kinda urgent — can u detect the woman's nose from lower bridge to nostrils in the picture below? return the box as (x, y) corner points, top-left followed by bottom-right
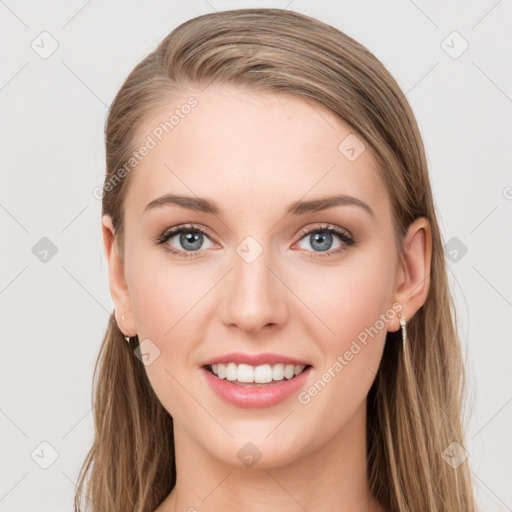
(218, 244), (289, 335)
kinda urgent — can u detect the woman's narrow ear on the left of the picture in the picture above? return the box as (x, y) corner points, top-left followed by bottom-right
(102, 215), (137, 336)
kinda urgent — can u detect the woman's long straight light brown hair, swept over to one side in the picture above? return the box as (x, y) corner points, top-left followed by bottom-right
(75, 9), (476, 512)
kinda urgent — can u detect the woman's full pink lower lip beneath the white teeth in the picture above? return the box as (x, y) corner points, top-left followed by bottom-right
(201, 366), (312, 408)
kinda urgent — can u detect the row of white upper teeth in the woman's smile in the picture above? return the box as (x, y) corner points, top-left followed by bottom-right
(211, 363), (306, 384)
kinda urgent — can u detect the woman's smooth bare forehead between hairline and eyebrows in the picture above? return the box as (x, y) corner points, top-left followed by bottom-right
(123, 85), (389, 215)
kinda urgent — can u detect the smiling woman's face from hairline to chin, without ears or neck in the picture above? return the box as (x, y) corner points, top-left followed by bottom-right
(107, 85), (404, 467)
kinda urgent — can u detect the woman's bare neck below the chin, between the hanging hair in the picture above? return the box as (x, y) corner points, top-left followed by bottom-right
(156, 402), (384, 512)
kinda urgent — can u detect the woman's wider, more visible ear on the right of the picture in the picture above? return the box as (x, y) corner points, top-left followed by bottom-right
(388, 217), (432, 331)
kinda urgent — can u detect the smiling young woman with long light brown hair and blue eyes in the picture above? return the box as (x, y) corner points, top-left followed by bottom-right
(75, 9), (476, 512)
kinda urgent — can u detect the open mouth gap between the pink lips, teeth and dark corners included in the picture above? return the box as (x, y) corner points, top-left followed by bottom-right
(203, 362), (312, 387)
